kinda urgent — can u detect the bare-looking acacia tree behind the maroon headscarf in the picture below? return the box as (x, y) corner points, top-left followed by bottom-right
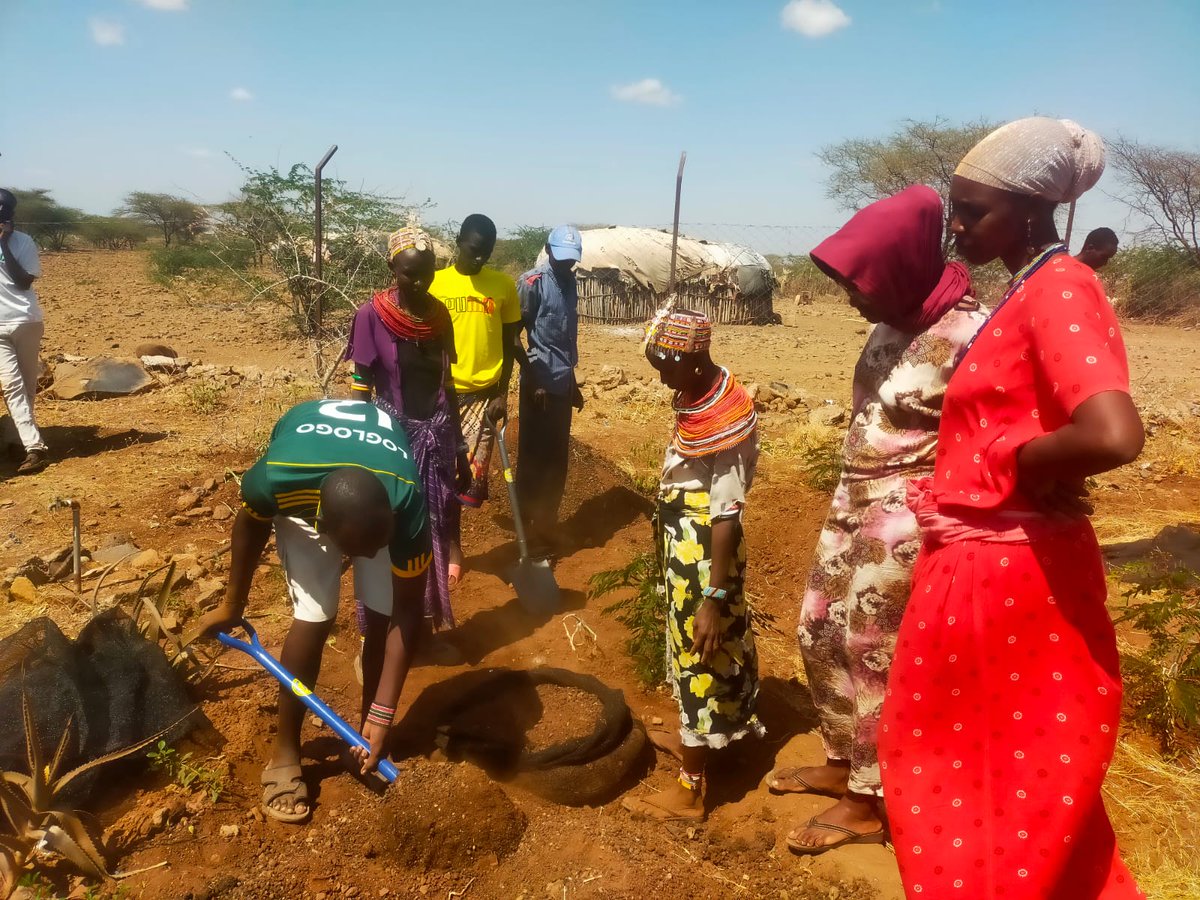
(817, 118), (996, 247)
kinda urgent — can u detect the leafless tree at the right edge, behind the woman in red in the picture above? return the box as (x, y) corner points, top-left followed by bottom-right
(1109, 137), (1200, 265)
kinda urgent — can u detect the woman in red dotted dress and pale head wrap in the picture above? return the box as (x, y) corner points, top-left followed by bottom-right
(880, 118), (1144, 900)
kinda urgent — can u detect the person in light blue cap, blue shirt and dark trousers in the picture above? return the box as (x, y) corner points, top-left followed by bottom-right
(516, 226), (583, 556)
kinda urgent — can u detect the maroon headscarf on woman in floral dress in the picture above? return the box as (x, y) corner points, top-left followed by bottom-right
(809, 185), (971, 334)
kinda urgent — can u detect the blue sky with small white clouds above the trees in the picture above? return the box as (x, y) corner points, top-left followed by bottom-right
(0, 0), (1200, 247)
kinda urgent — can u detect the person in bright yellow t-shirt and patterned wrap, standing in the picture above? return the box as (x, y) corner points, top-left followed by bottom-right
(430, 212), (521, 587)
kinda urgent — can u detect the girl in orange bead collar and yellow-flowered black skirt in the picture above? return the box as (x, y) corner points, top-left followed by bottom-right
(622, 310), (763, 821)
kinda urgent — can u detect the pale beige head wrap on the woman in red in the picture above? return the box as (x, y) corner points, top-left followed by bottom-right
(954, 116), (1104, 203)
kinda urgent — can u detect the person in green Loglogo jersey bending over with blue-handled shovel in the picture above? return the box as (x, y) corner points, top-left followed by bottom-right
(190, 400), (433, 823)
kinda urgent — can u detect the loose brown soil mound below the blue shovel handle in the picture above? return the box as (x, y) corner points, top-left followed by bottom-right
(337, 761), (527, 871)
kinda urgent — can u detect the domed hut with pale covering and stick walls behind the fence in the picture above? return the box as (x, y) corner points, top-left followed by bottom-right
(539, 226), (778, 325)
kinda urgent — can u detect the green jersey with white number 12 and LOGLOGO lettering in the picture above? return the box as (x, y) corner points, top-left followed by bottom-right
(241, 400), (433, 578)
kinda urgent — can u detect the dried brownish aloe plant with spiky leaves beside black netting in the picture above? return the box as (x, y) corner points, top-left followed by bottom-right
(0, 690), (191, 896)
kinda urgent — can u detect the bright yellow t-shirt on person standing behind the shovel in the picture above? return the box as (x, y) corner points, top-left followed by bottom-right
(430, 264), (521, 392)
